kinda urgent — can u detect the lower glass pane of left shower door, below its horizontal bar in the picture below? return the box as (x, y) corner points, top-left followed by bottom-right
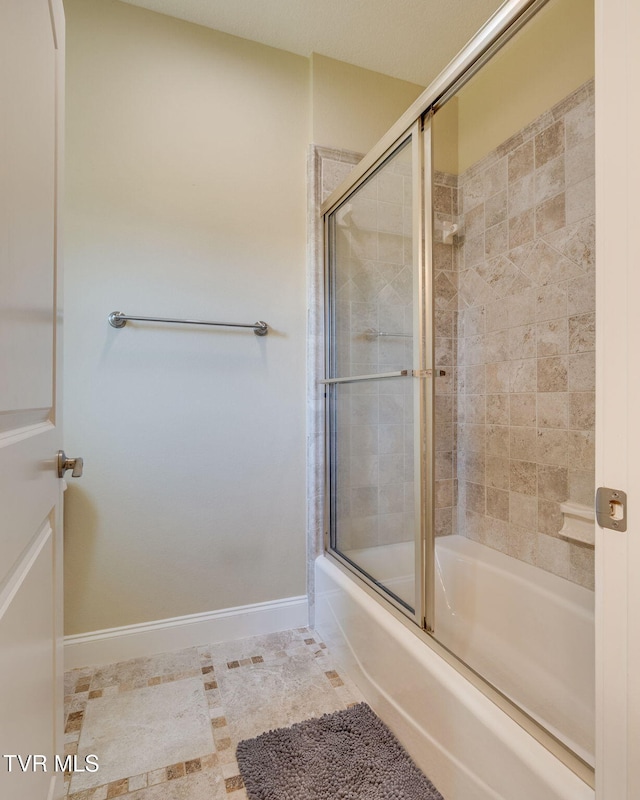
(330, 378), (416, 609)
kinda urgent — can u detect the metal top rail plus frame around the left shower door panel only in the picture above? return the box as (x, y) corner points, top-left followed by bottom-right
(321, 0), (548, 633)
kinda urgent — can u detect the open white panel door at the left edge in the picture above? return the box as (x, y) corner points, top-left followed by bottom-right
(0, 0), (64, 800)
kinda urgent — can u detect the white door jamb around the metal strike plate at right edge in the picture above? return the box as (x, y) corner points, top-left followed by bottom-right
(596, 0), (640, 800)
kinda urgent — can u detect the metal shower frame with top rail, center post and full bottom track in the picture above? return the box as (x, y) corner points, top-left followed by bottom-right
(321, 0), (595, 787)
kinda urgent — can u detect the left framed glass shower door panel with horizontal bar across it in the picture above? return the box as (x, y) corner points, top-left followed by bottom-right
(325, 120), (424, 619)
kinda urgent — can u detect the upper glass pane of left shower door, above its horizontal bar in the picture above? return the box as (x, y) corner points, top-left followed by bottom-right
(329, 139), (414, 378)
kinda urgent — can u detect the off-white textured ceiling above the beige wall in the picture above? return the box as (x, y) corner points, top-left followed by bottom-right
(123, 0), (502, 86)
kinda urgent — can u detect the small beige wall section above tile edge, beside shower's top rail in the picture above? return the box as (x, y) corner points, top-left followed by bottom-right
(311, 53), (424, 154)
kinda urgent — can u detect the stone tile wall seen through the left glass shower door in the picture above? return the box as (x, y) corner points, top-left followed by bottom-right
(336, 153), (414, 550)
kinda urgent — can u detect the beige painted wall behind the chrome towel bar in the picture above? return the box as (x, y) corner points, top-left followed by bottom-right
(65, 0), (419, 634)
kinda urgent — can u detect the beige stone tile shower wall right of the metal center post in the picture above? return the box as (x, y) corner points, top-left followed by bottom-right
(444, 82), (595, 586)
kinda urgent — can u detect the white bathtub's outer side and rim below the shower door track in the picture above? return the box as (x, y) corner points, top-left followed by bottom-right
(316, 556), (594, 800)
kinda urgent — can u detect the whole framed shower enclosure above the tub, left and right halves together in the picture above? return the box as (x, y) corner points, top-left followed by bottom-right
(324, 0), (596, 782)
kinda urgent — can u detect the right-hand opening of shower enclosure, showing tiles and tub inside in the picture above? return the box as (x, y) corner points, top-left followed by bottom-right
(428, 0), (596, 765)
